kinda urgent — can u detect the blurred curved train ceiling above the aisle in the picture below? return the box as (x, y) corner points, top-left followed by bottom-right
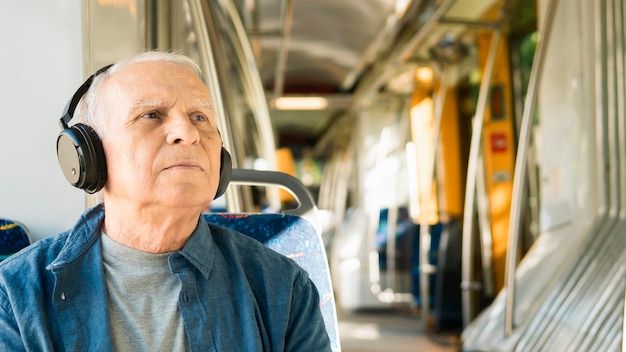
(236, 0), (535, 152)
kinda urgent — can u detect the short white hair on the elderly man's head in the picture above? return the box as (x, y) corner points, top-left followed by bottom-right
(75, 51), (202, 136)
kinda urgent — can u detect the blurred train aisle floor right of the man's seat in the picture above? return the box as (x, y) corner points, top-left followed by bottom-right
(339, 310), (458, 352)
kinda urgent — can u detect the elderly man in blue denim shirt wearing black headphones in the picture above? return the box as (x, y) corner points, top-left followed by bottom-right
(0, 52), (330, 351)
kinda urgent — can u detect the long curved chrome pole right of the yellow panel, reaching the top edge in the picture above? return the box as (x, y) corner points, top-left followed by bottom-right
(504, 0), (558, 336)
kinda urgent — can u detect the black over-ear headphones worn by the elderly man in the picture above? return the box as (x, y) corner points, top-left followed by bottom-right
(57, 65), (232, 198)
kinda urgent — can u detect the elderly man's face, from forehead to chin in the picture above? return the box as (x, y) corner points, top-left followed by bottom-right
(98, 62), (221, 209)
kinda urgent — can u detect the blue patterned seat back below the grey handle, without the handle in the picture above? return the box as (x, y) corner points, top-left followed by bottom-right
(204, 213), (340, 351)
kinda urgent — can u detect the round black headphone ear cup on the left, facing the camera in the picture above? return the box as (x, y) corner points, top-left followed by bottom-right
(57, 123), (107, 194)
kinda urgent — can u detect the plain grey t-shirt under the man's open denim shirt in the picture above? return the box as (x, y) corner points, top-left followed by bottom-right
(102, 233), (189, 351)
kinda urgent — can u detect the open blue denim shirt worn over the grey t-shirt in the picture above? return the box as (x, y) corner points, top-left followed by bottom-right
(0, 206), (330, 351)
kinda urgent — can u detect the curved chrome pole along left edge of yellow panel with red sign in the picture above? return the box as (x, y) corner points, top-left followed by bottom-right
(461, 29), (501, 326)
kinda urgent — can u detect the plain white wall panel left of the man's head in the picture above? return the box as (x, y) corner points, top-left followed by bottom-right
(0, 0), (85, 240)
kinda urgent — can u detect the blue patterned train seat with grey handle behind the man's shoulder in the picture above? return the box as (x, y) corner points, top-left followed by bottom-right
(204, 169), (341, 351)
